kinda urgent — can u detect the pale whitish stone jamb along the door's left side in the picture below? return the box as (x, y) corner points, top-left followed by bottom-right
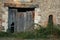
(2, 7), (8, 32)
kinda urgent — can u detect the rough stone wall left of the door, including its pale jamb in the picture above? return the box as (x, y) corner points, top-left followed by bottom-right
(0, 1), (8, 32)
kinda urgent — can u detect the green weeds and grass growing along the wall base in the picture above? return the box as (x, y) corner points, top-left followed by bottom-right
(0, 25), (60, 39)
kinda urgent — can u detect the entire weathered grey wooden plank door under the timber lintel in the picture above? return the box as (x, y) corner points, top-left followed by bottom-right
(8, 8), (34, 32)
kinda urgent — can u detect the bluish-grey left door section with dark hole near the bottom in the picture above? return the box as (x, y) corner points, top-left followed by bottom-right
(8, 9), (17, 32)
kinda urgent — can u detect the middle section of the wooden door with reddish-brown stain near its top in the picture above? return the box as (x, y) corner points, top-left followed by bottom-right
(16, 12), (24, 32)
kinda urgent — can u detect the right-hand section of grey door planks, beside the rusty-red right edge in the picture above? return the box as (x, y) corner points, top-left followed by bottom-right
(24, 11), (34, 31)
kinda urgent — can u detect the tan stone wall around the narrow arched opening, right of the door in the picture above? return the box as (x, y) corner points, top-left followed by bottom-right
(37, 0), (60, 26)
